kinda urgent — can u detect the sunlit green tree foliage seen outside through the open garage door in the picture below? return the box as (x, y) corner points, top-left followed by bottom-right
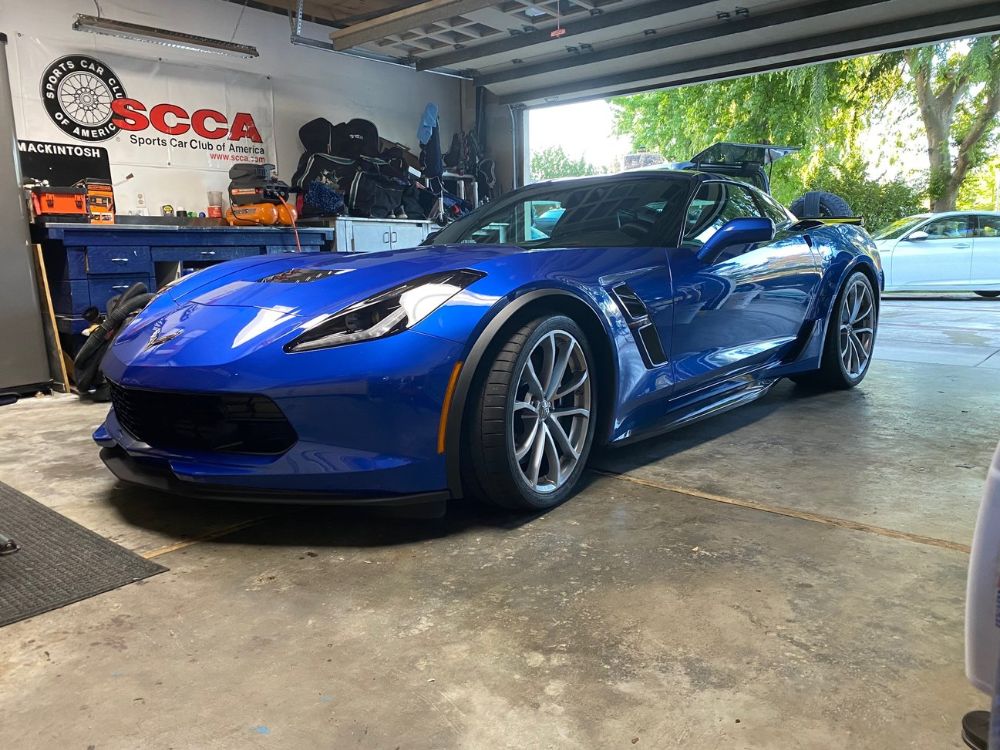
(612, 37), (1000, 216)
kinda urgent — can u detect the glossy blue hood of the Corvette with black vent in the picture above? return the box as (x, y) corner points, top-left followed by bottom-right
(168, 245), (532, 317)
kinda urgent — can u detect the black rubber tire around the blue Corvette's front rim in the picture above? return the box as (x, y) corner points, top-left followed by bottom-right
(462, 314), (597, 510)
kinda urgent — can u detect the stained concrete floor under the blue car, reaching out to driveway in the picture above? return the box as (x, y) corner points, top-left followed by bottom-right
(0, 299), (1000, 750)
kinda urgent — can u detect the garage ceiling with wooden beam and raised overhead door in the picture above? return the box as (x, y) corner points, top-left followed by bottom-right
(270, 0), (1000, 105)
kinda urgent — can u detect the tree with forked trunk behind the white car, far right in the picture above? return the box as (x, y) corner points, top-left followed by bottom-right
(905, 36), (1000, 211)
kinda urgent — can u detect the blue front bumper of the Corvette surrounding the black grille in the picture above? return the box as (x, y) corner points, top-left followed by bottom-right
(94, 319), (461, 504)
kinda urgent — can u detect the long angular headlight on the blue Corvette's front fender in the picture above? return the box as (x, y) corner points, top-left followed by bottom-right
(285, 269), (486, 352)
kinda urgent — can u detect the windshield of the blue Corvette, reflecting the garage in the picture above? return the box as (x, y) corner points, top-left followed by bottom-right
(433, 175), (690, 248)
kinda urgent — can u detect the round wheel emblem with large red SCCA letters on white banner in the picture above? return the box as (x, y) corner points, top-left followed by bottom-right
(42, 55), (262, 143)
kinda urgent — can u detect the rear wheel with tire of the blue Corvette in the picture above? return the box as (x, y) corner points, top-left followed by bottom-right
(792, 271), (878, 389)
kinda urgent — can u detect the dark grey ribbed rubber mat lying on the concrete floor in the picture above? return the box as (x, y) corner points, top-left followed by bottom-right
(0, 482), (167, 627)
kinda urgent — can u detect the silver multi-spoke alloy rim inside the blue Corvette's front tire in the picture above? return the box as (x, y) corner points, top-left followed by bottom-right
(508, 329), (592, 494)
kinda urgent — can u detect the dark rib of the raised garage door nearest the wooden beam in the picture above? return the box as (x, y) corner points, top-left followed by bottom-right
(416, 0), (716, 70)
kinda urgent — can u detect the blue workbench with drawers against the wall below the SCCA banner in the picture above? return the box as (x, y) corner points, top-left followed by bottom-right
(36, 223), (334, 334)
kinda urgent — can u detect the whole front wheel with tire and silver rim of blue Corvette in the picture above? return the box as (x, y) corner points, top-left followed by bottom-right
(463, 315), (597, 510)
